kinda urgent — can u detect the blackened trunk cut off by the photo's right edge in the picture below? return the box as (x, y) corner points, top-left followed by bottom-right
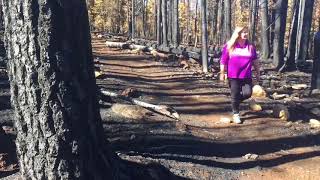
(311, 31), (320, 89)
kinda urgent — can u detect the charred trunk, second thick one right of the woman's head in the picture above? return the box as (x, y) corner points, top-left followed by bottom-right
(273, 0), (288, 70)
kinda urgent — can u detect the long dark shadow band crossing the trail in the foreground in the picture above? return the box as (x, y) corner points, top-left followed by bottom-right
(112, 126), (320, 170)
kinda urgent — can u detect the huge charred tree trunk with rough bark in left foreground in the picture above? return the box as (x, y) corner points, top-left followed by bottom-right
(3, 0), (119, 179)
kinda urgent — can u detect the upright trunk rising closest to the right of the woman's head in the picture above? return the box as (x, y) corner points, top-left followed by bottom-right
(260, 0), (270, 59)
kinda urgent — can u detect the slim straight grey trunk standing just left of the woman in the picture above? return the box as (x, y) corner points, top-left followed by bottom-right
(201, 0), (208, 73)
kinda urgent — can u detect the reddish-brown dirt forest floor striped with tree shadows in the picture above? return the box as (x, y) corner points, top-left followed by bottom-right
(0, 39), (320, 180)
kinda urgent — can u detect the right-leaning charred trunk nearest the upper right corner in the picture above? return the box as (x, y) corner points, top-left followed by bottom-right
(295, 0), (314, 69)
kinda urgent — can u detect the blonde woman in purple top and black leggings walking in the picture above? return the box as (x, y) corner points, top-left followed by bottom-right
(220, 27), (260, 124)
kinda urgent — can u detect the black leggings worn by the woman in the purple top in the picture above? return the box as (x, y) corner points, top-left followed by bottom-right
(229, 78), (252, 114)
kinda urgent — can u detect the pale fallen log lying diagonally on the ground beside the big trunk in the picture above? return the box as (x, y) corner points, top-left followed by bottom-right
(101, 90), (180, 119)
